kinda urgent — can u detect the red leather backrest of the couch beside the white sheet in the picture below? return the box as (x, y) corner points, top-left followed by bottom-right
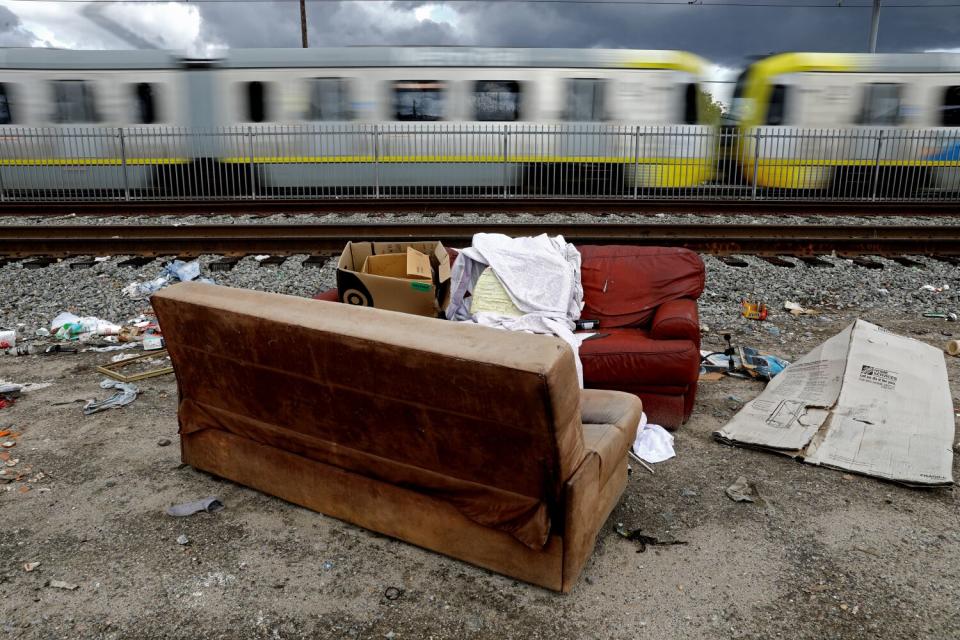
(577, 245), (705, 331)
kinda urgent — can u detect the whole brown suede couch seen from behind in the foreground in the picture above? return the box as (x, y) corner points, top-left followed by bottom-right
(152, 283), (641, 592)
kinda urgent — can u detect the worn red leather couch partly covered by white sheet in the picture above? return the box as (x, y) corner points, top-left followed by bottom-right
(316, 245), (706, 429)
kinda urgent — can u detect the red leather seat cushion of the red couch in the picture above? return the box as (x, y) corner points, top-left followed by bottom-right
(580, 324), (700, 393)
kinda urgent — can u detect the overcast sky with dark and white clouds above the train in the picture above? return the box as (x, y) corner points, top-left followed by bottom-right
(0, 0), (960, 100)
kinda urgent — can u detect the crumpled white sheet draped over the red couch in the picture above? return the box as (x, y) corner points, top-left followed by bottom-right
(446, 233), (588, 388)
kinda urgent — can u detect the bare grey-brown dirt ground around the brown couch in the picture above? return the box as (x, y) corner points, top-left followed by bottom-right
(0, 310), (960, 640)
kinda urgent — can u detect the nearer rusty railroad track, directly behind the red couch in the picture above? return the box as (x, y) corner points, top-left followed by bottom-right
(0, 223), (960, 264)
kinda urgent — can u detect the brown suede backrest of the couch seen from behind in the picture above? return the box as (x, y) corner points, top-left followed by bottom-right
(152, 283), (584, 544)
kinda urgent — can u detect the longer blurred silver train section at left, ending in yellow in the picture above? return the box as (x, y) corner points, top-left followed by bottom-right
(0, 47), (715, 195)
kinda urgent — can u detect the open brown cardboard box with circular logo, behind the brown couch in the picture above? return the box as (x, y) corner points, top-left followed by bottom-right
(337, 242), (450, 318)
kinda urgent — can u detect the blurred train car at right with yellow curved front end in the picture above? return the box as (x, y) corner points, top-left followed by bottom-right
(724, 53), (960, 197)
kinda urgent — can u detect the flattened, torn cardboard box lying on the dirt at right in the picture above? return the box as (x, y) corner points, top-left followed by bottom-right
(714, 320), (954, 486)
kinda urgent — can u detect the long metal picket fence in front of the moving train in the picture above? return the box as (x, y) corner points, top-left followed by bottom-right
(0, 123), (960, 203)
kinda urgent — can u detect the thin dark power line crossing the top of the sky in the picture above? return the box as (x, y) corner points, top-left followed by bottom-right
(6, 0), (960, 9)
